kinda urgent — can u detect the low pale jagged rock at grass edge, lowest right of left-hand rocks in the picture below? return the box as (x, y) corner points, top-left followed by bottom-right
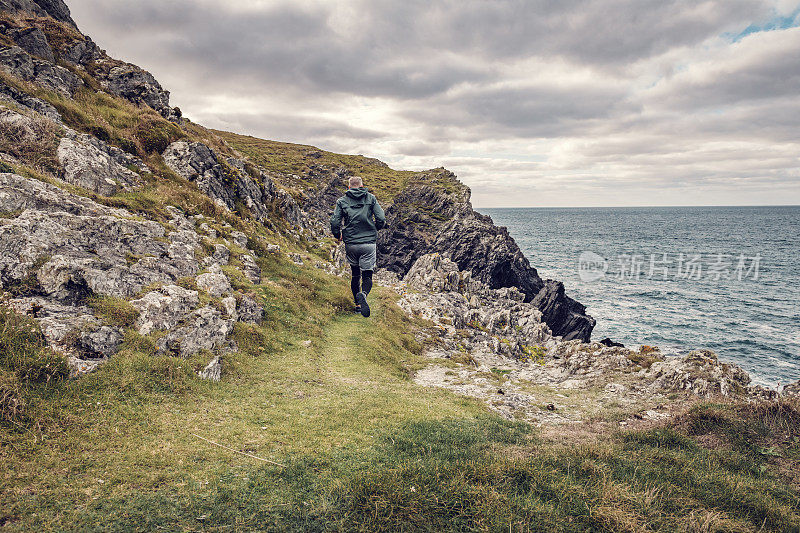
(157, 306), (234, 357)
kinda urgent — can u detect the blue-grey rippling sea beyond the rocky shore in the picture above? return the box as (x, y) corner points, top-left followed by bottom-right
(478, 206), (800, 388)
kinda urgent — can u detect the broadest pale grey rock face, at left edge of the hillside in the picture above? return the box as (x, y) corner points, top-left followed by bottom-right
(0, 174), (199, 303)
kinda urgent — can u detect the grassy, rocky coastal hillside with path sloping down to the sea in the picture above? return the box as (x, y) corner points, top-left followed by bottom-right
(0, 0), (800, 531)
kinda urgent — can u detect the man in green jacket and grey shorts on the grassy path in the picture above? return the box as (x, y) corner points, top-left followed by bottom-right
(331, 176), (386, 317)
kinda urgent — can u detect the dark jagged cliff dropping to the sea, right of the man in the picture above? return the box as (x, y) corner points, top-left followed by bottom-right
(378, 170), (595, 341)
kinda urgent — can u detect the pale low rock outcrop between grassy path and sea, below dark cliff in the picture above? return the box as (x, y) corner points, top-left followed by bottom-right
(398, 254), (775, 423)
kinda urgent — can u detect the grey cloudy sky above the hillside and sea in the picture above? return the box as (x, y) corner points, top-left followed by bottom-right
(67, 0), (800, 207)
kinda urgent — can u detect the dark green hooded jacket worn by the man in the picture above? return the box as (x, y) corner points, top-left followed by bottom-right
(331, 187), (386, 244)
